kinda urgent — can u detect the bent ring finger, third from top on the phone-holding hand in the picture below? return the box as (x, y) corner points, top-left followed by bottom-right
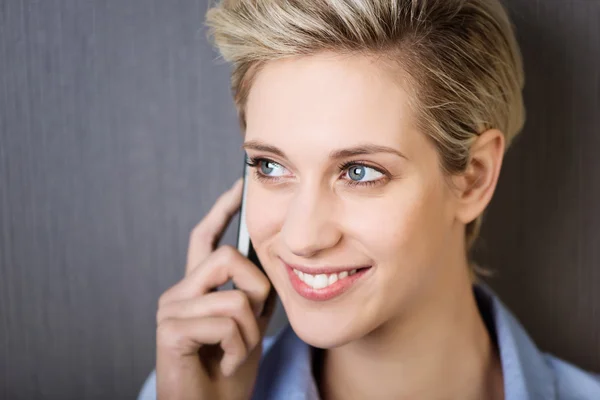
(156, 290), (261, 350)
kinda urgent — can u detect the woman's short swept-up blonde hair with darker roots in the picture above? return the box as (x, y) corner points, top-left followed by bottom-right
(206, 0), (525, 276)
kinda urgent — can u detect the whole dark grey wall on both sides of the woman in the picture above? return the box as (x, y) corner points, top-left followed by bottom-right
(0, 0), (600, 400)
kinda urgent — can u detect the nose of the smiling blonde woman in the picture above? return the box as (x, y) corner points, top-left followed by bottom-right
(281, 184), (342, 257)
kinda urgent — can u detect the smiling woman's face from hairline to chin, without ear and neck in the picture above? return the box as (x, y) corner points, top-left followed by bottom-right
(245, 54), (463, 348)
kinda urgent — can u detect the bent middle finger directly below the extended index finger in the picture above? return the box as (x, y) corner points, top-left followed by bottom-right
(176, 246), (271, 313)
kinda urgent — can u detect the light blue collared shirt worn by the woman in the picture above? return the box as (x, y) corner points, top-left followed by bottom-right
(138, 283), (600, 400)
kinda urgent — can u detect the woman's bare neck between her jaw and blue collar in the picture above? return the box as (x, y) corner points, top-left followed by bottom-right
(315, 268), (504, 400)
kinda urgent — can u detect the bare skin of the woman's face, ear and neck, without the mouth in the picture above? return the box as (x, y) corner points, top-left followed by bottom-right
(244, 53), (505, 400)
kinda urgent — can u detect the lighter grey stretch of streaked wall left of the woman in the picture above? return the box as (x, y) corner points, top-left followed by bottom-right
(0, 0), (243, 399)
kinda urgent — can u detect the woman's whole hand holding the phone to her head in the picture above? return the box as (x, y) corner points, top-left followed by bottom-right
(156, 179), (274, 400)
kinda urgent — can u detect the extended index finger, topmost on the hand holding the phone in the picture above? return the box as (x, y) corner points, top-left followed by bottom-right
(186, 178), (243, 275)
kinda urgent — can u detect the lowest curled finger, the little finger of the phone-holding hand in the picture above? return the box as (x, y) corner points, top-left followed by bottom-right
(156, 317), (248, 376)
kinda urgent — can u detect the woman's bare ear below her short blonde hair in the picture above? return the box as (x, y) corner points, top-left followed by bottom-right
(452, 129), (505, 225)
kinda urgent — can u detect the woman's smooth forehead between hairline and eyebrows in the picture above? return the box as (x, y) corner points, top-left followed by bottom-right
(246, 55), (412, 156)
